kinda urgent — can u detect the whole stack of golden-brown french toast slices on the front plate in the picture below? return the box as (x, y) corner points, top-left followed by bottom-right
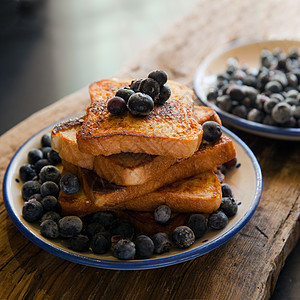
(51, 79), (236, 232)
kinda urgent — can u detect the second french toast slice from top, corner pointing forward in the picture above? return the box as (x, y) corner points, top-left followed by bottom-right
(51, 106), (221, 185)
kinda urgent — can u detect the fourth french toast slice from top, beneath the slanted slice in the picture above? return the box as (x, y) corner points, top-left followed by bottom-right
(59, 171), (222, 216)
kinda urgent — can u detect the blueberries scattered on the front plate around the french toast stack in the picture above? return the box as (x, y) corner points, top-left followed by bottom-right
(19, 132), (238, 260)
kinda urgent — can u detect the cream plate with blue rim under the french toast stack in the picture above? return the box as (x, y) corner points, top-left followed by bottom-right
(3, 116), (262, 270)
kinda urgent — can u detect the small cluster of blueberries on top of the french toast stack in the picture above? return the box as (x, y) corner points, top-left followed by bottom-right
(107, 70), (171, 116)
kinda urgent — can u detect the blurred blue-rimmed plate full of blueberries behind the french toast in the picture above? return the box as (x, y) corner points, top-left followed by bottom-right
(194, 40), (300, 141)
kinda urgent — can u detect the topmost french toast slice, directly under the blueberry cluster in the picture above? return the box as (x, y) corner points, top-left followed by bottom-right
(77, 79), (203, 158)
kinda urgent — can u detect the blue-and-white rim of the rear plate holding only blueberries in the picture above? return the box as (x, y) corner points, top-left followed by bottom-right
(193, 39), (300, 140)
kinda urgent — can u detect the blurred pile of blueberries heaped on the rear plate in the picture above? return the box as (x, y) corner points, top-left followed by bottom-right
(207, 48), (300, 128)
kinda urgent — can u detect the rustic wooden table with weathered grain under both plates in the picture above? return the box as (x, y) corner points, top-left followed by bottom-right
(0, 0), (300, 299)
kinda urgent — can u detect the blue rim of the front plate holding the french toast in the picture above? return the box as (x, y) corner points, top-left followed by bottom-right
(3, 114), (263, 270)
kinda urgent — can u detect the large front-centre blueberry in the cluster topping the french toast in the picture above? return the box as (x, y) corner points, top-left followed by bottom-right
(127, 93), (154, 116)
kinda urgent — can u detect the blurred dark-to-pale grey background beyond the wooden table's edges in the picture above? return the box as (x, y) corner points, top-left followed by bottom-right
(0, 0), (300, 300)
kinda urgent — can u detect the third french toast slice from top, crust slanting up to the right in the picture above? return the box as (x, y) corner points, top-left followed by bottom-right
(62, 135), (236, 215)
